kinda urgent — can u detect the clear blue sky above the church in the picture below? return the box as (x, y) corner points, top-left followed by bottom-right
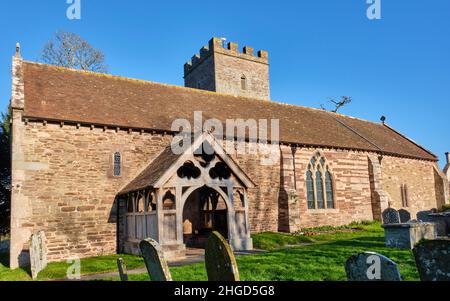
(0, 0), (450, 165)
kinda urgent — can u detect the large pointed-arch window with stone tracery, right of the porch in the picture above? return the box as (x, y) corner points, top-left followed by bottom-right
(306, 152), (335, 209)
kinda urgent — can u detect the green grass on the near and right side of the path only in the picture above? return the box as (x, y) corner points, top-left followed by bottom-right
(107, 223), (419, 281)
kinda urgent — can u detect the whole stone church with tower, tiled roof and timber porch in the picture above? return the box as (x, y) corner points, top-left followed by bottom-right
(10, 38), (449, 268)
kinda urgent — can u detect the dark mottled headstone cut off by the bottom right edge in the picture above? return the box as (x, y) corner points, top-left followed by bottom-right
(413, 239), (450, 281)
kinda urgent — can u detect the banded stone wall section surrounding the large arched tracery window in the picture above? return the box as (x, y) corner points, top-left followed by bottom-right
(283, 147), (373, 232)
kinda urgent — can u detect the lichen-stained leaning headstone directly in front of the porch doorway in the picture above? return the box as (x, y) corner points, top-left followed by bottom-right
(205, 231), (239, 281)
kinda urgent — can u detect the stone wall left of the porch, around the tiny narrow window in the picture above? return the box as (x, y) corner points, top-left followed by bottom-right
(12, 120), (171, 261)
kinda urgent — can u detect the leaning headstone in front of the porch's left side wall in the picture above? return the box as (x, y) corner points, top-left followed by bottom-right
(139, 238), (172, 281)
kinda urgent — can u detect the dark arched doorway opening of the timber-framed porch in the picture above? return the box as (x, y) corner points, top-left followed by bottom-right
(183, 186), (229, 248)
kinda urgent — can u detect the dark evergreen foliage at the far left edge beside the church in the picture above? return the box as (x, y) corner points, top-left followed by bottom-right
(0, 107), (11, 236)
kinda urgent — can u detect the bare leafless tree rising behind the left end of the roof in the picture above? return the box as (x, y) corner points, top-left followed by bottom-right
(42, 31), (108, 73)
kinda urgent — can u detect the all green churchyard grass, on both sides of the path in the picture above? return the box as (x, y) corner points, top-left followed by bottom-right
(0, 223), (419, 281)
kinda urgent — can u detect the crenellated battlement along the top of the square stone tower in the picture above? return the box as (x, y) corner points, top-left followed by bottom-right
(184, 38), (269, 76)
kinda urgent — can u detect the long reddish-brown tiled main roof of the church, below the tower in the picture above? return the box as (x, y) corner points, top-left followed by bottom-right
(23, 62), (437, 161)
